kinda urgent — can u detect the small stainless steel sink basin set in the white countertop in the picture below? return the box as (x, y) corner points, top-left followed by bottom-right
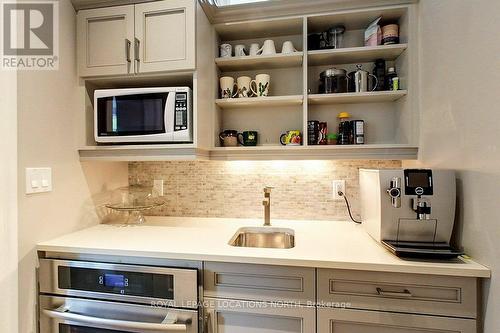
(229, 227), (295, 249)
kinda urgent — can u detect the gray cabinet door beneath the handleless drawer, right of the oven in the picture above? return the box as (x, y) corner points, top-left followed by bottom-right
(204, 298), (316, 333)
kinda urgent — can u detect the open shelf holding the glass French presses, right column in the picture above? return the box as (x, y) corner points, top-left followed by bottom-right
(307, 90), (408, 105)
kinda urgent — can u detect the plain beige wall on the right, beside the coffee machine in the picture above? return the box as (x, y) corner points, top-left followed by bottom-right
(414, 0), (500, 333)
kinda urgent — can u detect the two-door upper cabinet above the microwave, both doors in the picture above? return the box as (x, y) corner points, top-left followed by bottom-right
(77, 0), (196, 77)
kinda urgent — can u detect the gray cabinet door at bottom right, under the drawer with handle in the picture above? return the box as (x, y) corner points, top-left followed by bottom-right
(318, 308), (476, 333)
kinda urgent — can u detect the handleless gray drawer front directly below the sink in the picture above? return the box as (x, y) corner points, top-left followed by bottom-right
(203, 262), (315, 304)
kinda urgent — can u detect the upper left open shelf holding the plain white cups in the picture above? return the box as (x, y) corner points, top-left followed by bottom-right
(215, 52), (304, 72)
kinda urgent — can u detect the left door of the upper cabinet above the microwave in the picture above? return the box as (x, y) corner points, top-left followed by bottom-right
(77, 5), (134, 76)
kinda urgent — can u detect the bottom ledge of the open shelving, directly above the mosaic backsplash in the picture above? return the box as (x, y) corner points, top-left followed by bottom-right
(210, 144), (418, 160)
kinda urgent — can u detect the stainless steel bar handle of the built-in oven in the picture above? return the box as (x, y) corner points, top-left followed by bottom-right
(43, 307), (187, 332)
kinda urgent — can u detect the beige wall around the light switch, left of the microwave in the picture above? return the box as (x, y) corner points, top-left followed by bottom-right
(17, 0), (127, 333)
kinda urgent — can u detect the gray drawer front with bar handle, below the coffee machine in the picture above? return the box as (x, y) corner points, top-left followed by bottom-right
(318, 269), (477, 318)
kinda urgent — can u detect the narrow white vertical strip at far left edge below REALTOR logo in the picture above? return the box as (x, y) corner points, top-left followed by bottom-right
(0, 58), (17, 333)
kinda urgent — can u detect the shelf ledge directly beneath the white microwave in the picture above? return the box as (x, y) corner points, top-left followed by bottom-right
(78, 144), (209, 161)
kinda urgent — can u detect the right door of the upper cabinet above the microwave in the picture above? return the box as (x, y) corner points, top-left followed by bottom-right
(135, 0), (196, 73)
